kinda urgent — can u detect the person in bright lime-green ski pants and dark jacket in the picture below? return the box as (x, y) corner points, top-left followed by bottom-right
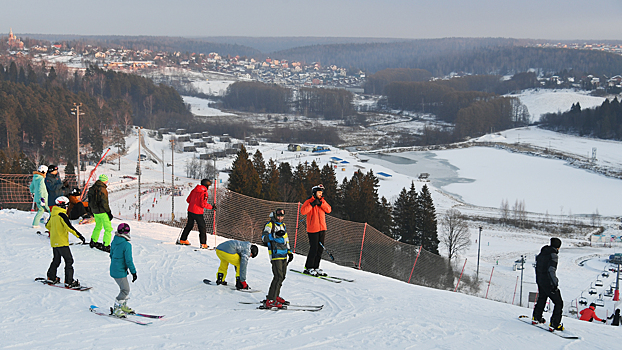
(88, 174), (113, 253)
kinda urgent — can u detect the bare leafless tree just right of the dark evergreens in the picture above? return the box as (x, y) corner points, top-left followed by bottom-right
(441, 209), (471, 260)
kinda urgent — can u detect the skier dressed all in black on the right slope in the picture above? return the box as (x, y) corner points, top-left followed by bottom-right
(531, 237), (564, 331)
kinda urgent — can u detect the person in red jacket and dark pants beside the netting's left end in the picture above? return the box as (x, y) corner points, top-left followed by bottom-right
(177, 179), (216, 249)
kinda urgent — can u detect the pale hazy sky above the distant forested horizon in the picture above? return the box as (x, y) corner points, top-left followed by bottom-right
(0, 0), (622, 40)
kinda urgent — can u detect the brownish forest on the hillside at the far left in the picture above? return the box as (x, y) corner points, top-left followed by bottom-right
(0, 59), (192, 171)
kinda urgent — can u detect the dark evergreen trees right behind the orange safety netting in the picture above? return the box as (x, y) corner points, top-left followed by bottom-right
(227, 147), (439, 254)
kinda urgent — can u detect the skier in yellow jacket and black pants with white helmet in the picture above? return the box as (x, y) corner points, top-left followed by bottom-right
(45, 196), (86, 288)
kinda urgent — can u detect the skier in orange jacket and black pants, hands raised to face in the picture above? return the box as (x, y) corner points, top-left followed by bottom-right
(300, 184), (332, 276)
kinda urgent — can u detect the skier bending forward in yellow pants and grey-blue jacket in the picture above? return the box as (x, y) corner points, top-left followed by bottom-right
(216, 240), (259, 289)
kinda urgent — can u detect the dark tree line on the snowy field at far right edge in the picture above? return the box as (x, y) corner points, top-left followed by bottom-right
(540, 97), (622, 140)
